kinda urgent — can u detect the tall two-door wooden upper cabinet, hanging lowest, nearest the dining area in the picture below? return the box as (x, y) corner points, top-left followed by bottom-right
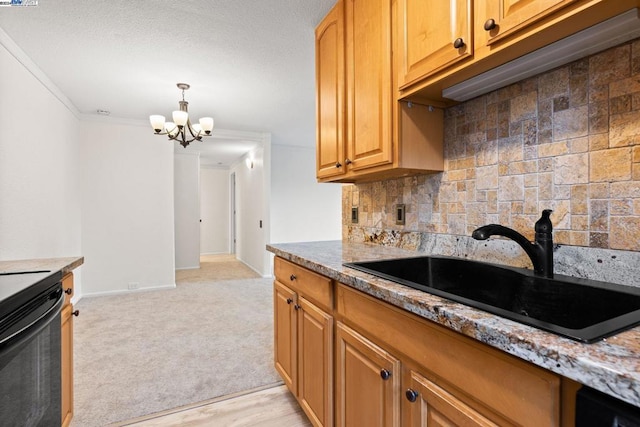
(316, 0), (442, 182)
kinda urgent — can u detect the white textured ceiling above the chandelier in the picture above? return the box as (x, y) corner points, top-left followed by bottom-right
(0, 0), (335, 165)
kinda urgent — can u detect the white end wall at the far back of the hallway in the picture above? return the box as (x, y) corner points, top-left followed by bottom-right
(200, 166), (230, 254)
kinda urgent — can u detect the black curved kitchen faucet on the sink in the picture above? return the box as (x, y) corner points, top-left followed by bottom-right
(471, 209), (553, 277)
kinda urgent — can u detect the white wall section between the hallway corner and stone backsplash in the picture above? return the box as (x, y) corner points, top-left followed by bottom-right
(270, 144), (342, 243)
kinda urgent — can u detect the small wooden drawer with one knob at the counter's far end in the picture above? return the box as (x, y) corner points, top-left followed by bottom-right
(274, 257), (333, 312)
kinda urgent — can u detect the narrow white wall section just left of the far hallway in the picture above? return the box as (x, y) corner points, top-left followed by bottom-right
(174, 154), (200, 269)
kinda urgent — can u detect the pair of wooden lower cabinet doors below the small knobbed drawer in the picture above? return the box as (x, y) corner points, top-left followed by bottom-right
(274, 280), (333, 427)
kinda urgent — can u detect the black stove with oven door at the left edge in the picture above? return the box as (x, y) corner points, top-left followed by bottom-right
(0, 271), (64, 427)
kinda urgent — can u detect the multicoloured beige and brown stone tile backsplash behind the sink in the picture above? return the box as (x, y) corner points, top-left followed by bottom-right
(343, 39), (640, 258)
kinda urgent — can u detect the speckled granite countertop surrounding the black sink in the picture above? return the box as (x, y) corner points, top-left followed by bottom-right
(267, 241), (640, 407)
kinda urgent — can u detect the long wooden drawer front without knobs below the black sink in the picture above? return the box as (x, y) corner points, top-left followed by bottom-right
(336, 284), (560, 426)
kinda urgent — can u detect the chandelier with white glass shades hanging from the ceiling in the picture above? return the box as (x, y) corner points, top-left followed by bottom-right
(149, 83), (213, 148)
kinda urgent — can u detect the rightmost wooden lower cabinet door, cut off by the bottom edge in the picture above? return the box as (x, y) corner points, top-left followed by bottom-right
(403, 370), (497, 427)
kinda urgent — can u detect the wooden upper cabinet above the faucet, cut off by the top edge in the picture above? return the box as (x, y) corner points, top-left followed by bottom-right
(394, 0), (640, 102)
